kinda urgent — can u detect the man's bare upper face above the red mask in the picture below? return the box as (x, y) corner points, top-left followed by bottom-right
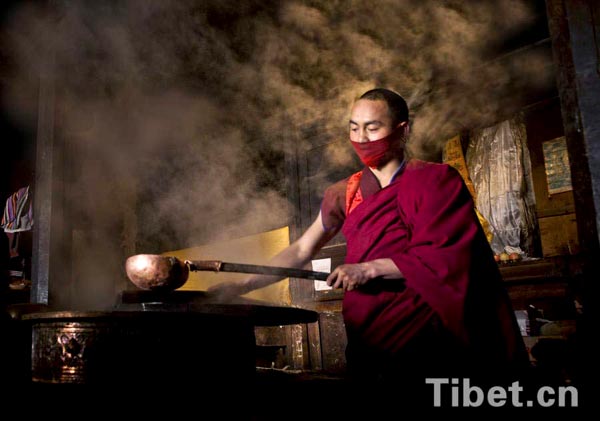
(350, 99), (394, 143)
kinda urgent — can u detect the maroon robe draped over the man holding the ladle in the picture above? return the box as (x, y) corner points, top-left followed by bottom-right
(321, 160), (527, 378)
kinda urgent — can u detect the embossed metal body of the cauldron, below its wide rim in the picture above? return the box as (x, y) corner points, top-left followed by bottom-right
(23, 311), (255, 388)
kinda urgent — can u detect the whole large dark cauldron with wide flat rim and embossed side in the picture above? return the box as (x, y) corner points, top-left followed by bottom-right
(21, 291), (318, 393)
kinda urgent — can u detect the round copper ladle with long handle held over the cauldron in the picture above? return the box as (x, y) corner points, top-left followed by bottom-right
(125, 254), (329, 291)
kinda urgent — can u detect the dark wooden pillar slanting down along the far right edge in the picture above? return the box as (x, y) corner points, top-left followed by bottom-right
(546, 0), (600, 402)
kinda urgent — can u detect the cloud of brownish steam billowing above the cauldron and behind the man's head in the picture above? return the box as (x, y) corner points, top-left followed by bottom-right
(3, 0), (549, 308)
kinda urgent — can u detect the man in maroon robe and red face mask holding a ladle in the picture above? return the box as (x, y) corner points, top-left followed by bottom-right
(211, 88), (528, 398)
